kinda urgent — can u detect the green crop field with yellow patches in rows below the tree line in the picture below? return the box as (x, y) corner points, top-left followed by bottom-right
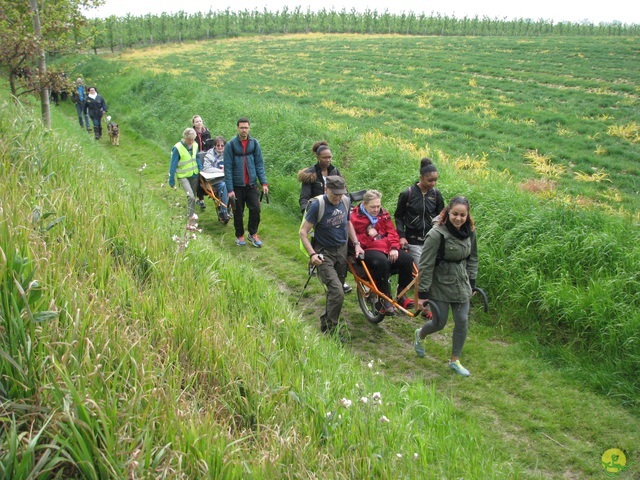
(124, 35), (640, 214)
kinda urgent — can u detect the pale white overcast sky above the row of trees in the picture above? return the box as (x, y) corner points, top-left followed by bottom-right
(87, 0), (640, 25)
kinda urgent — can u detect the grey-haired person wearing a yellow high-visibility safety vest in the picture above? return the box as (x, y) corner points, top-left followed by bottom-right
(169, 128), (202, 221)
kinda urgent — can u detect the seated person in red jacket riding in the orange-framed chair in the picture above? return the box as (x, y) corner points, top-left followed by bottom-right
(351, 190), (413, 316)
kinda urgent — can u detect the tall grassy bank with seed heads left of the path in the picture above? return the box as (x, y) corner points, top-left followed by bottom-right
(0, 96), (518, 479)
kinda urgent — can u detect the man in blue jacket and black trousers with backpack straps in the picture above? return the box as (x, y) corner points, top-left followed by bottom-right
(224, 117), (269, 248)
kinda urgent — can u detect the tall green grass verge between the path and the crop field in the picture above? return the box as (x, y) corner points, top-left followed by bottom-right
(63, 39), (640, 405)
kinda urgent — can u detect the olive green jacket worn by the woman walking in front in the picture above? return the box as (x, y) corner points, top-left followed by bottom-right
(418, 225), (478, 303)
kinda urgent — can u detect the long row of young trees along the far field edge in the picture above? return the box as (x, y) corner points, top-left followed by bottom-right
(91, 7), (640, 53)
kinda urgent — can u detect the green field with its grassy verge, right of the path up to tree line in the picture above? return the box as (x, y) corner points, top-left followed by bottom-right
(71, 35), (640, 405)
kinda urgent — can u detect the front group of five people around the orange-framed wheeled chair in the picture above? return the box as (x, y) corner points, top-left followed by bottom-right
(298, 142), (478, 376)
